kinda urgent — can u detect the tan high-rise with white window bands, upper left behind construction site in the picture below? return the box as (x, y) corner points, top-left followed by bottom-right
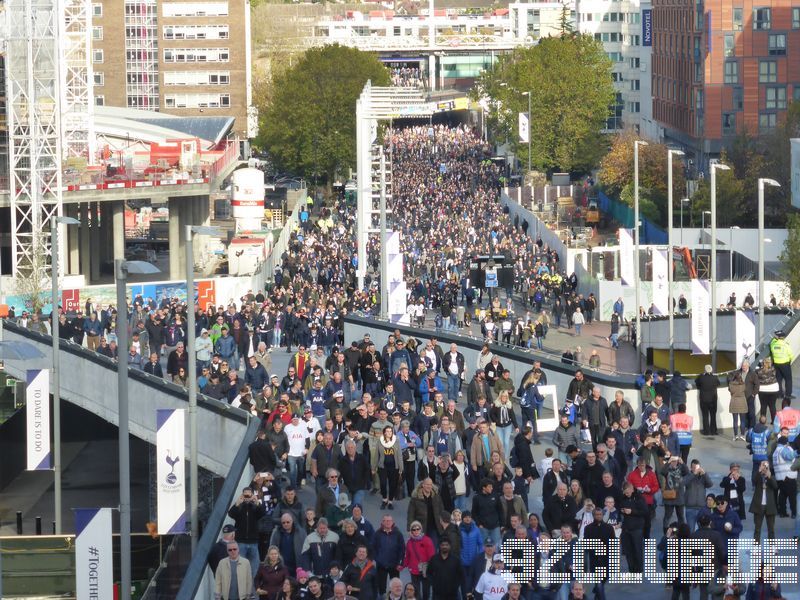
(92, 0), (255, 138)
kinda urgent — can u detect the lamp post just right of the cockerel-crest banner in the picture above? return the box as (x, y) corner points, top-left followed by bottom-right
(185, 225), (221, 554)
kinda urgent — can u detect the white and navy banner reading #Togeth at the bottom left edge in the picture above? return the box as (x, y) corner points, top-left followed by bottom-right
(75, 508), (114, 600)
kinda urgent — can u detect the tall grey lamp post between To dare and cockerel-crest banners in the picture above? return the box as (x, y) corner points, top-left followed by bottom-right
(114, 258), (159, 597)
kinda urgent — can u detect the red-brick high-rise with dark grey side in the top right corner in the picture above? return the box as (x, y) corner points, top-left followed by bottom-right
(653, 0), (800, 164)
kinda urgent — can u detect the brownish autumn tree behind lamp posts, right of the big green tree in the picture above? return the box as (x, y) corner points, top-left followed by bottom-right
(599, 130), (686, 225)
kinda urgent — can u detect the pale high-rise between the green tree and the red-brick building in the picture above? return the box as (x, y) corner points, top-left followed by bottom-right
(577, 0), (660, 137)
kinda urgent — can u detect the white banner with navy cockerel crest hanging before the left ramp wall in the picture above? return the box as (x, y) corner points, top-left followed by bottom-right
(156, 408), (186, 535)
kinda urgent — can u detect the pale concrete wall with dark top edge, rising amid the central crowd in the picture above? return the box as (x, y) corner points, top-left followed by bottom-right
(345, 316), (736, 431)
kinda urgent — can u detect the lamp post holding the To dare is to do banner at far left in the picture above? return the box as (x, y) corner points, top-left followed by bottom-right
(50, 217), (81, 535)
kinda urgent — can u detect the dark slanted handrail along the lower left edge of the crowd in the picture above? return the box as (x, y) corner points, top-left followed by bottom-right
(176, 419), (260, 600)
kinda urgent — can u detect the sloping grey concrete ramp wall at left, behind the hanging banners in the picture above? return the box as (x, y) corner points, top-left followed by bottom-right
(3, 324), (248, 477)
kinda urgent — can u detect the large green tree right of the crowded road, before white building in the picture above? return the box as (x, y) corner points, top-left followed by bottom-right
(473, 34), (615, 172)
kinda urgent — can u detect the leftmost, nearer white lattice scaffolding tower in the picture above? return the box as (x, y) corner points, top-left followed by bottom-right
(4, 0), (62, 278)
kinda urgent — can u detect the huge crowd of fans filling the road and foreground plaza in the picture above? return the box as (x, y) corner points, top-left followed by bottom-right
(3, 126), (800, 600)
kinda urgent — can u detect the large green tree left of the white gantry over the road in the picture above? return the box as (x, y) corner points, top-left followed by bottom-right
(256, 44), (389, 183)
